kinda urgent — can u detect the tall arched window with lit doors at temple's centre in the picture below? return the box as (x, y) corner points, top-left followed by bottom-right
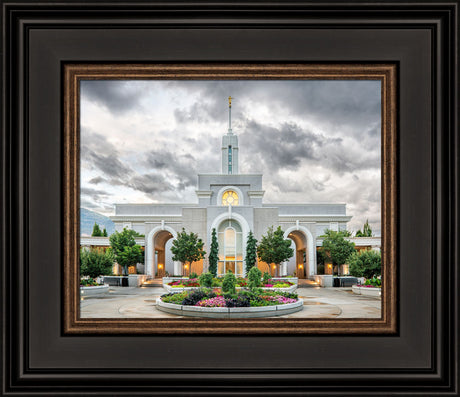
(217, 219), (243, 277)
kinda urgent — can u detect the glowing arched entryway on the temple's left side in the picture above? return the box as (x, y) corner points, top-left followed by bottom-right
(145, 226), (177, 277)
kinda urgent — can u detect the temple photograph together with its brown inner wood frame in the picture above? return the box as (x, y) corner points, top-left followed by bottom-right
(64, 64), (397, 334)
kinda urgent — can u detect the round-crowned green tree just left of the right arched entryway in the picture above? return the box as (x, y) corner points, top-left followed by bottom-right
(257, 226), (294, 274)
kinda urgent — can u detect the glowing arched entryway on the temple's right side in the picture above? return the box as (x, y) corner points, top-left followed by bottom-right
(284, 225), (316, 278)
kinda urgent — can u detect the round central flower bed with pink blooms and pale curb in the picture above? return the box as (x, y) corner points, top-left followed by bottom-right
(157, 288), (303, 317)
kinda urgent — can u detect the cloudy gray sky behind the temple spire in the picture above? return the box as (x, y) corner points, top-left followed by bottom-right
(81, 80), (381, 235)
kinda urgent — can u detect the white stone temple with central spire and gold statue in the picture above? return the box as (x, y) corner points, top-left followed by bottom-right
(111, 97), (354, 278)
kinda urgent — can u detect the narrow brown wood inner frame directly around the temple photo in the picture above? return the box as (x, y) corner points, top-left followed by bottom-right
(63, 64), (397, 334)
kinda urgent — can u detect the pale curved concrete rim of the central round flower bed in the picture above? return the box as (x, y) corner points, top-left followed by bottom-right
(156, 298), (303, 319)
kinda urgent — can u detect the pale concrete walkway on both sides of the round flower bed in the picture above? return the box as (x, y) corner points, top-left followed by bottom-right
(81, 280), (381, 318)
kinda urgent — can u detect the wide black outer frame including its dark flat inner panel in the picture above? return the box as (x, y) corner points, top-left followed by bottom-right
(1, 0), (460, 396)
